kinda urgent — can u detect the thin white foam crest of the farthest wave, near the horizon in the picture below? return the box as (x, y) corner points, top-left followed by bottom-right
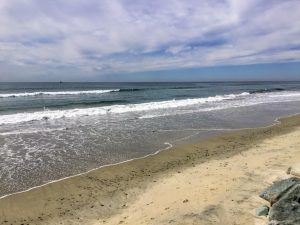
(0, 89), (119, 98)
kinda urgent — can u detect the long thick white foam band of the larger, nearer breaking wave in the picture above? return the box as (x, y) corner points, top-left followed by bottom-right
(0, 93), (248, 124)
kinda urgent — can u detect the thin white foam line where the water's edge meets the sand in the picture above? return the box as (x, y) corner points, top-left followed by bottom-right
(0, 113), (294, 200)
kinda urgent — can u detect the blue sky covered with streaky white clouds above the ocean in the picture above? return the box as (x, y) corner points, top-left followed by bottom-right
(0, 0), (300, 82)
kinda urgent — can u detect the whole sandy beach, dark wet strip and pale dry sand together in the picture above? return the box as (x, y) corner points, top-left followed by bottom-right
(0, 116), (300, 225)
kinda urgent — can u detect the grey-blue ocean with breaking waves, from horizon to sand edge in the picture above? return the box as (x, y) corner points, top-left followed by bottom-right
(0, 82), (300, 196)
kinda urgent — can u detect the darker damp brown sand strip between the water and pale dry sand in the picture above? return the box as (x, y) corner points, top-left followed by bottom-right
(0, 114), (300, 224)
